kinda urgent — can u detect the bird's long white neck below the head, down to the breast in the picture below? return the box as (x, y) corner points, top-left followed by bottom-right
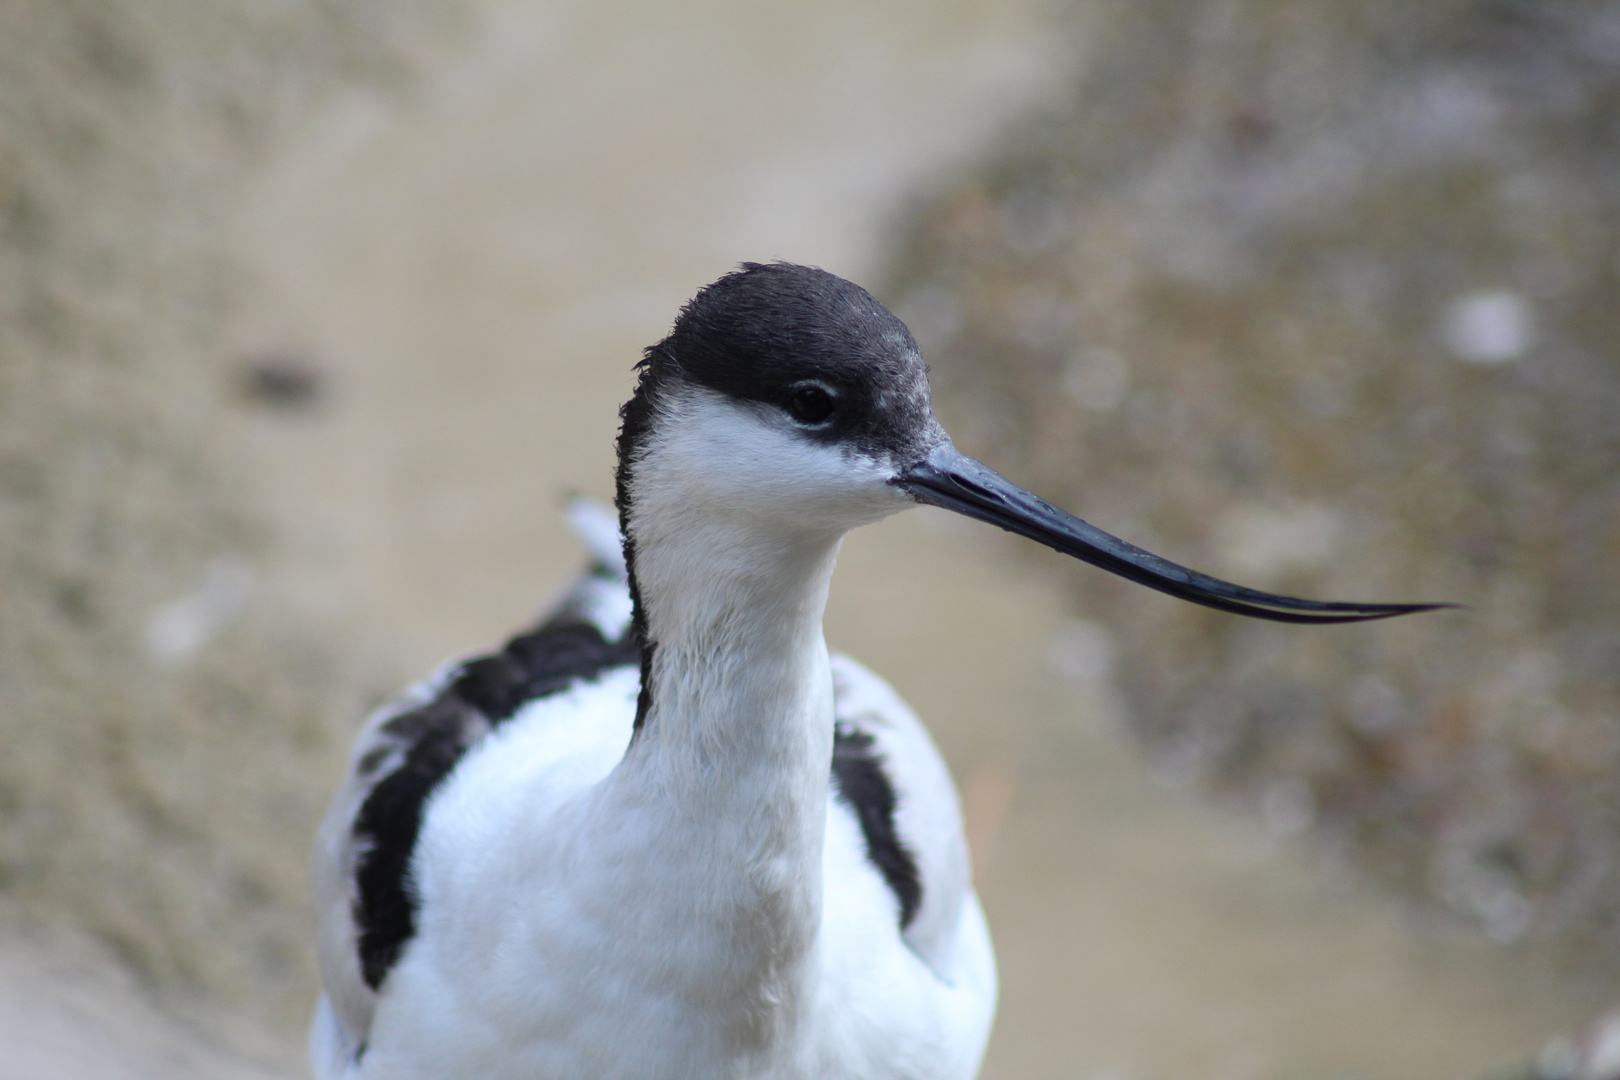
(601, 484), (839, 1061)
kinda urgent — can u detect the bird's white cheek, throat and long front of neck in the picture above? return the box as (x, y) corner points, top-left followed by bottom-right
(583, 392), (907, 1064)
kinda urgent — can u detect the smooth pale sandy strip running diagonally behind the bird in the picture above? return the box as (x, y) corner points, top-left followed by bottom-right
(0, 0), (1599, 1080)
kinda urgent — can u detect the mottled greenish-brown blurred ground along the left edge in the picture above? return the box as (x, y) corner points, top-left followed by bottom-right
(0, 0), (443, 1049)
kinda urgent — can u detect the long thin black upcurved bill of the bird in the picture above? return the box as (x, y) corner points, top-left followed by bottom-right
(889, 442), (1456, 623)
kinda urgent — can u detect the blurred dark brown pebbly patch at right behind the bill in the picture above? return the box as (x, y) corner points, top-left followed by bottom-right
(891, 0), (1620, 957)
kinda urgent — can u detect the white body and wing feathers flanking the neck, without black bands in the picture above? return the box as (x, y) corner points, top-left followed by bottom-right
(311, 504), (995, 1080)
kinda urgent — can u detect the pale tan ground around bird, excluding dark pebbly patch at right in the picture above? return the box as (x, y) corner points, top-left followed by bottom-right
(0, 0), (1612, 1080)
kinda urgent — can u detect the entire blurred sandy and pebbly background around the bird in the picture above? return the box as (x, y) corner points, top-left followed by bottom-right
(0, 0), (1620, 1080)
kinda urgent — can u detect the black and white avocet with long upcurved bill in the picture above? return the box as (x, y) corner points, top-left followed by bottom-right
(311, 264), (1430, 1080)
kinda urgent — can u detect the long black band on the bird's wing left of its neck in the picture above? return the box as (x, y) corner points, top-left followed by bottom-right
(355, 612), (640, 989)
